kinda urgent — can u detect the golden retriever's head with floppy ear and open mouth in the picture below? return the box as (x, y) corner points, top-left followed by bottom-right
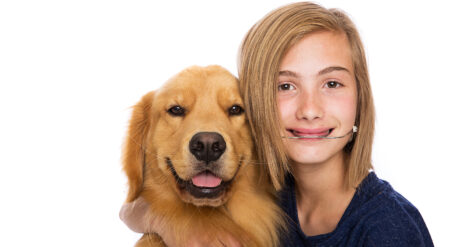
(124, 66), (252, 207)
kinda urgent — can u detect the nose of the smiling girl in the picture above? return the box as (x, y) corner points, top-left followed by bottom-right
(296, 92), (324, 120)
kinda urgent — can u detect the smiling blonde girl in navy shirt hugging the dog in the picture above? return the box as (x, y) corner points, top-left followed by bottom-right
(121, 3), (433, 246)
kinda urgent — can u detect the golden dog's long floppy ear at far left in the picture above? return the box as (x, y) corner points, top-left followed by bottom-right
(123, 92), (154, 202)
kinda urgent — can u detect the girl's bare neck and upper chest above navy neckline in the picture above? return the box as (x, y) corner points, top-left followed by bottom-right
(292, 152), (355, 236)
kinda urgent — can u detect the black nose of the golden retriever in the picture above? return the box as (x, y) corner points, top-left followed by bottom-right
(189, 132), (226, 164)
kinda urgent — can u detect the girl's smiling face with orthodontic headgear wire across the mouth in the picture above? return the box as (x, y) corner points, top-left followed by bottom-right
(277, 31), (357, 164)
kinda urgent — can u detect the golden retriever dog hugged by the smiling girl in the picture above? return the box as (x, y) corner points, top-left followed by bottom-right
(123, 66), (283, 247)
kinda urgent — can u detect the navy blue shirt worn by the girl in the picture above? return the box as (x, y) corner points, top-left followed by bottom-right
(279, 172), (433, 247)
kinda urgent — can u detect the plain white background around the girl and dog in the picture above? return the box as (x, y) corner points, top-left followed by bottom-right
(0, 0), (454, 246)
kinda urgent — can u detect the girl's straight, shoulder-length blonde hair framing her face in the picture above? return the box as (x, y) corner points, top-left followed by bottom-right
(238, 2), (375, 189)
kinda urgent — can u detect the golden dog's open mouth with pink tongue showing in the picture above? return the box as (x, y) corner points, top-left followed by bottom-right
(166, 158), (233, 199)
